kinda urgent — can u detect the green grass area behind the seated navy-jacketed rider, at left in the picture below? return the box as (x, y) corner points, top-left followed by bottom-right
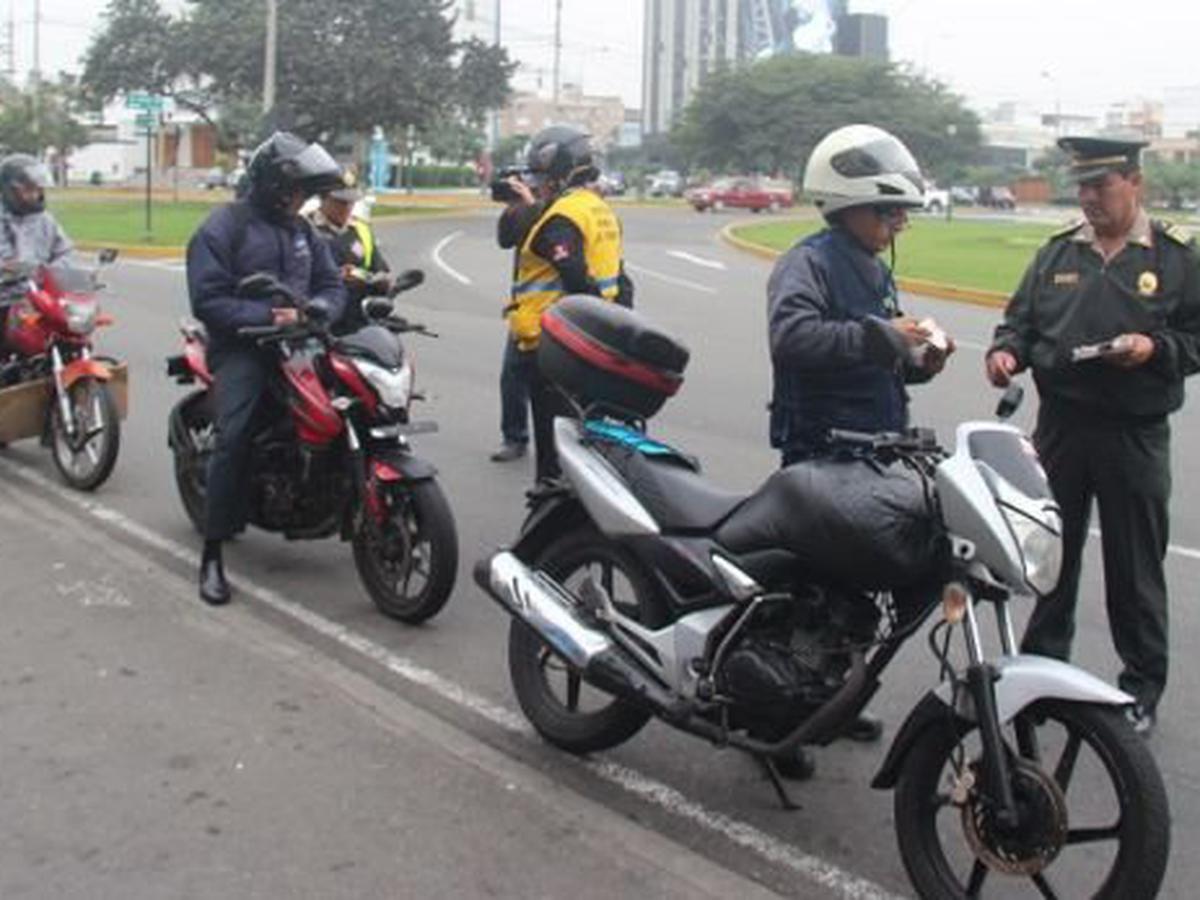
(49, 198), (444, 247)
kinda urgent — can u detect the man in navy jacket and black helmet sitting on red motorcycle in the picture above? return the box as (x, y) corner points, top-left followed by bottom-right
(187, 132), (346, 605)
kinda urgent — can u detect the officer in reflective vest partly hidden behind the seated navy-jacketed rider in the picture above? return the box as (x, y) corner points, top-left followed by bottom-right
(307, 172), (392, 334)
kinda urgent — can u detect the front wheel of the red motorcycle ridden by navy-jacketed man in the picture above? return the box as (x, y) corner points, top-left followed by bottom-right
(354, 479), (458, 625)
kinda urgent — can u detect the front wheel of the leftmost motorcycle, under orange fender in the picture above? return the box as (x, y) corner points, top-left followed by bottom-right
(49, 378), (121, 491)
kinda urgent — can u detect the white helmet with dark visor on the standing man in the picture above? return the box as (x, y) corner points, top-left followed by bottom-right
(804, 125), (925, 216)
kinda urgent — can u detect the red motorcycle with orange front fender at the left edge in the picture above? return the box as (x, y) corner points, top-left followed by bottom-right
(0, 250), (127, 491)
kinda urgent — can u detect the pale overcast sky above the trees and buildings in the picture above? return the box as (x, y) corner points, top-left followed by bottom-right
(14, 0), (1200, 121)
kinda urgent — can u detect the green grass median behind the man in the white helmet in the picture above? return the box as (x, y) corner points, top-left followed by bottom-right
(733, 216), (1062, 293)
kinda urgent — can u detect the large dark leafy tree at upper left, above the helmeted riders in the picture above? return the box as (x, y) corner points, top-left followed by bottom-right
(84, 0), (514, 148)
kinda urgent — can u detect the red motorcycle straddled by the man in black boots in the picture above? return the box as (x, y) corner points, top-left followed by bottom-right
(167, 271), (458, 624)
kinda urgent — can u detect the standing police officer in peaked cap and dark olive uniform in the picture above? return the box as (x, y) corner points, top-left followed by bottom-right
(986, 138), (1200, 734)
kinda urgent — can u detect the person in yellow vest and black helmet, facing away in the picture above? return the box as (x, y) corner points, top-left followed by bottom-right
(506, 125), (634, 486)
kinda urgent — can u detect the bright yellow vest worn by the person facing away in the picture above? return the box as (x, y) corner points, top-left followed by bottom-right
(509, 188), (622, 350)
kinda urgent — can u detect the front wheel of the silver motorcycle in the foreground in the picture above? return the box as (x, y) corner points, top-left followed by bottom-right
(894, 700), (1170, 900)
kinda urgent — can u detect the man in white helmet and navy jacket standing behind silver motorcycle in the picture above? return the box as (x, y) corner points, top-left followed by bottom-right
(767, 125), (954, 778)
